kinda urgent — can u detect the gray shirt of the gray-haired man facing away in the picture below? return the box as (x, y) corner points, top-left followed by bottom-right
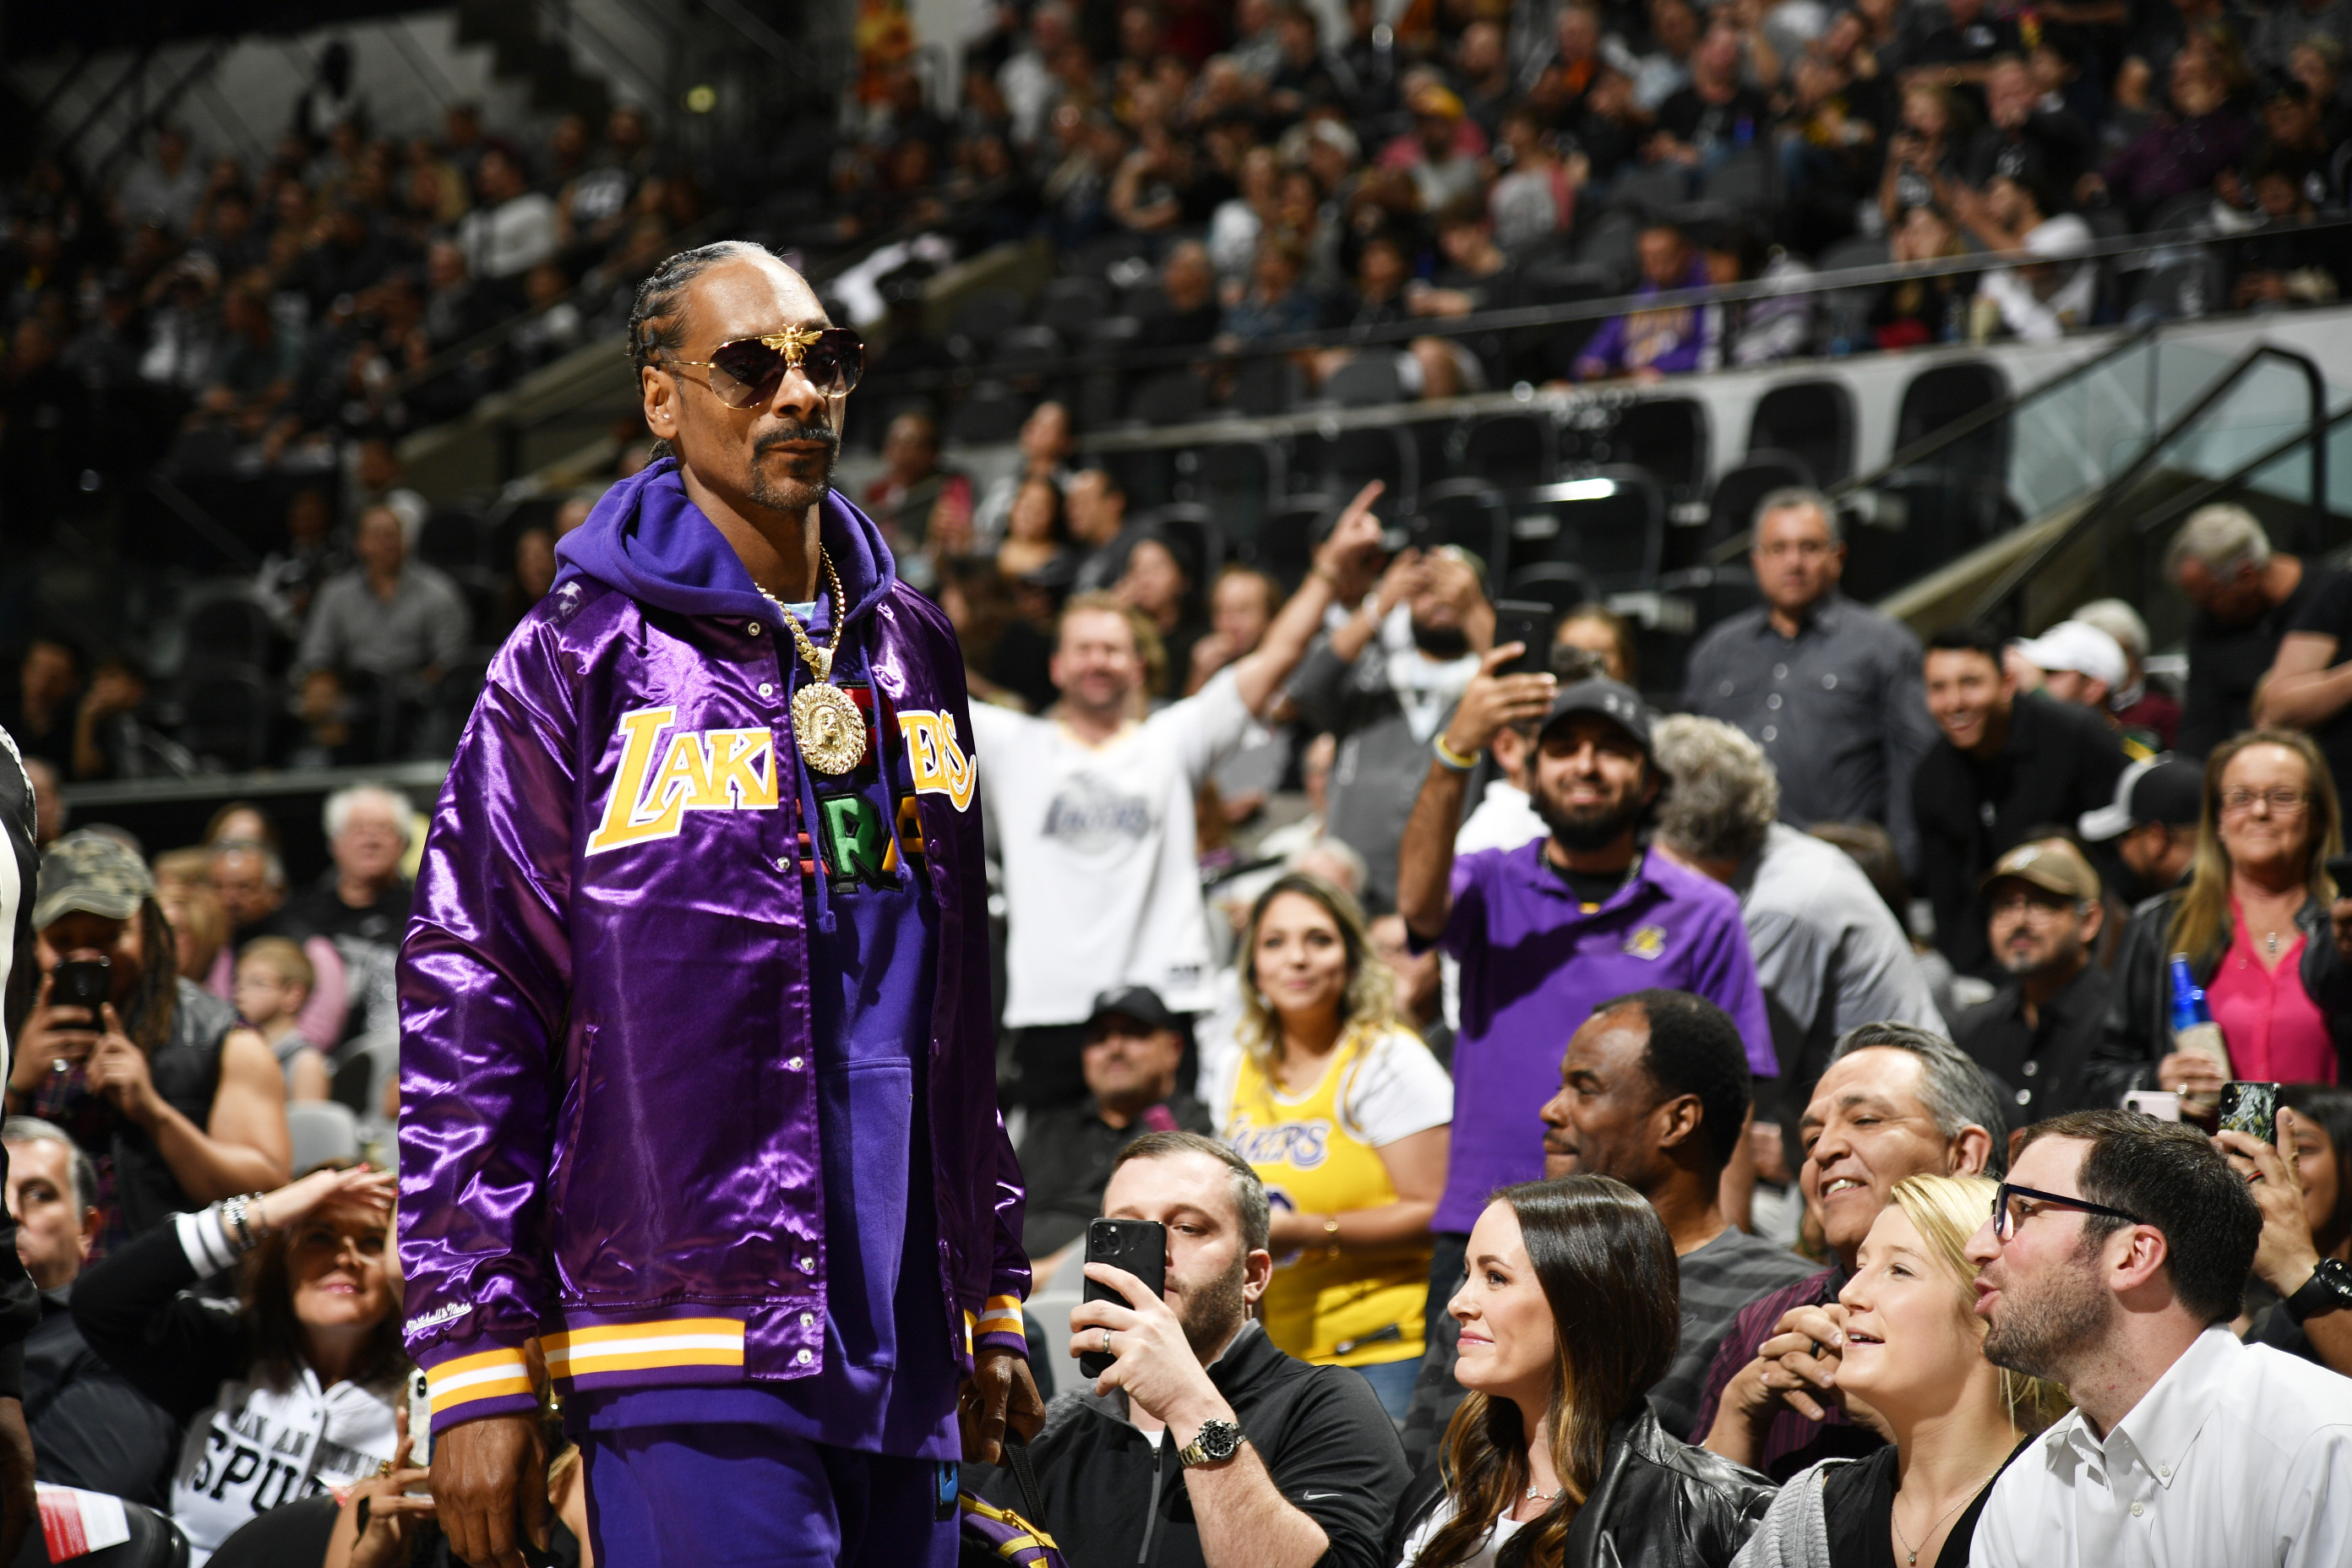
(1731, 823), (1950, 1091)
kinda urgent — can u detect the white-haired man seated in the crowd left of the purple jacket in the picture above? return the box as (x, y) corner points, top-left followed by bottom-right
(289, 783), (421, 1039)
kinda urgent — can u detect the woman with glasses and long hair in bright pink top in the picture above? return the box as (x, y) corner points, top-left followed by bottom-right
(2088, 729), (2352, 1100)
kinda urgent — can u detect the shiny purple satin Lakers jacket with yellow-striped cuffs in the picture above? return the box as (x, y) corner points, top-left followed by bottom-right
(400, 463), (1028, 1424)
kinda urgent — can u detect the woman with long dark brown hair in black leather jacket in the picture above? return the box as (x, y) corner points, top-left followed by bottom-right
(1390, 1175), (1773, 1568)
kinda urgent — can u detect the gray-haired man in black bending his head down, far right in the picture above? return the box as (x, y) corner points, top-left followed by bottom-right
(2164, 505), (2343, 762)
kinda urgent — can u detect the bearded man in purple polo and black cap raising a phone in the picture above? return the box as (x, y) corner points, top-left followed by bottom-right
(1397, 677), (1778, 1476)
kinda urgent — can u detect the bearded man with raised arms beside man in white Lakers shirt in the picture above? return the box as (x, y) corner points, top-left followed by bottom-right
(1291, 546), (1494, 912)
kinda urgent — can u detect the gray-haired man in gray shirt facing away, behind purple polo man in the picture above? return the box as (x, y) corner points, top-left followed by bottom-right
(1651, 715), (1945, 1133)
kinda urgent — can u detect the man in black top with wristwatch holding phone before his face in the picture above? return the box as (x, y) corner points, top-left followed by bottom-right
(969, 1133), (1409, 1568)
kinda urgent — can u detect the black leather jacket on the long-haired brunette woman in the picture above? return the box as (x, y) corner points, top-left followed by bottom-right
(1383, 1399), (1780, 1568)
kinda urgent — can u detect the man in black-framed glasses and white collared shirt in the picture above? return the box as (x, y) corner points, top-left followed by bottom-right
(1968, 1109), (2352, 1568)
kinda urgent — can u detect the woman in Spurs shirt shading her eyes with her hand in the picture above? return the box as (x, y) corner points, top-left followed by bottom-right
(73, 1166), (407, 1568)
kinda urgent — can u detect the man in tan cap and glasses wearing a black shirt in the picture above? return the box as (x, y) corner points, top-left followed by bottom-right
(1952, 839), (2107, 1130)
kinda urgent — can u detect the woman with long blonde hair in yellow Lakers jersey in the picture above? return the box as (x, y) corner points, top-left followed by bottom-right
(1204, 872), (1454, 1420)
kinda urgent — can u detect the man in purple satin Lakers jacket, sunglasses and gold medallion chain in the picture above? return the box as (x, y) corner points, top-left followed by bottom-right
(400, 244), (1042, 1568)
